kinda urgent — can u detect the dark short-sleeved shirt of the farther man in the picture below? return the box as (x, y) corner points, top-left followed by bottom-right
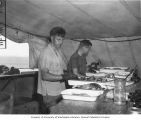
(67, 52), (87, 75)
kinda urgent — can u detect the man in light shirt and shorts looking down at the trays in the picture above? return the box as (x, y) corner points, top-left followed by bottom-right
(37, 27), (76, 110)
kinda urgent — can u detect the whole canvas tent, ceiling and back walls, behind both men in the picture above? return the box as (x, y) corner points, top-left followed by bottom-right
(0, 0), (141, 72)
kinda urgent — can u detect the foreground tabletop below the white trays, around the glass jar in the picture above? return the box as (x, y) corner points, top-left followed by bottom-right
(50, 82), (141, 114)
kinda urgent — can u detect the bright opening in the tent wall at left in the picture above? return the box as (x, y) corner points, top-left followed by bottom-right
(0, 36), (29, 68)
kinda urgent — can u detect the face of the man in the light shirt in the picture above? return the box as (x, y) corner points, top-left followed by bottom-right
(51, 35), (64, 48)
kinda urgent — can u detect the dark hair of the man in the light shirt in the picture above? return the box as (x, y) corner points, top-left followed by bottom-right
(50, 27), (66, 37)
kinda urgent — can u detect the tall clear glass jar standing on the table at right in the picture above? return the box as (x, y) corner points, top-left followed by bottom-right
(114, 78), (126, 105)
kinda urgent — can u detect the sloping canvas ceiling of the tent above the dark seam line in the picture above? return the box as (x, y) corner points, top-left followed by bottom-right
(2, 0), (141, 39)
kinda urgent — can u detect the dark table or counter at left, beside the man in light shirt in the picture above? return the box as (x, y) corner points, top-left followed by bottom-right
(0, 71), (39, 114)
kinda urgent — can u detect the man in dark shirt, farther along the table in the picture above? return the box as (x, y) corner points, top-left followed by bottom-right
(67, 40), (92, 77)
